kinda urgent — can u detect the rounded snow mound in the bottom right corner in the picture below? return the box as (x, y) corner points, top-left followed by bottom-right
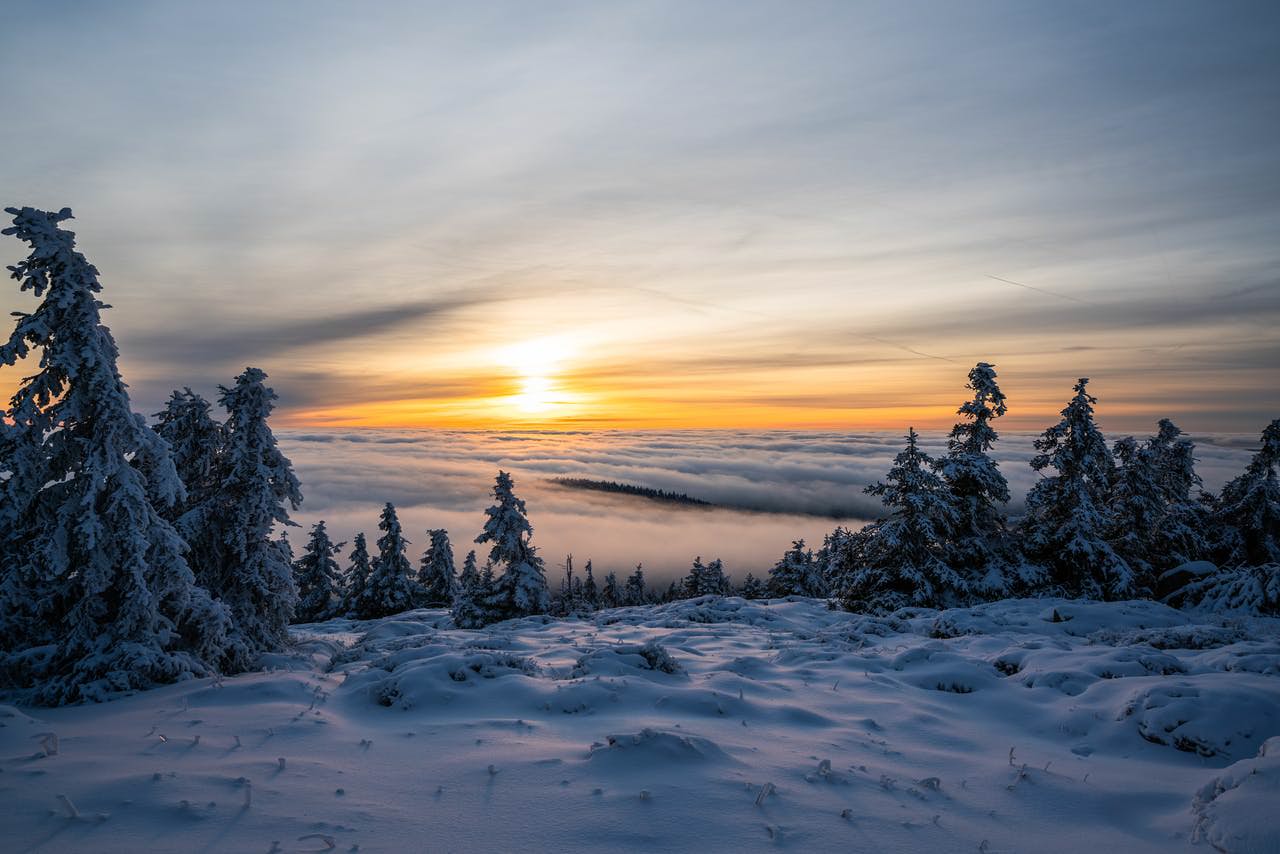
(1192, 737), (1280, 854)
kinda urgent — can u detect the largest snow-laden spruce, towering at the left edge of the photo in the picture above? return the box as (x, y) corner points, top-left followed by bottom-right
(0, 207), (227, 704)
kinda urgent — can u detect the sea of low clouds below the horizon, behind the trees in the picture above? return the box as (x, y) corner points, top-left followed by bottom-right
(279, 429), (1256, 583)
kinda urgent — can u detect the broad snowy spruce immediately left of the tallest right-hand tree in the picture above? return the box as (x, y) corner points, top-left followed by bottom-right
(837, 429), (966, 613)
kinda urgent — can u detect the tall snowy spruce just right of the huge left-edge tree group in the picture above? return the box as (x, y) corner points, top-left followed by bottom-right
(200, 367), (302, 671)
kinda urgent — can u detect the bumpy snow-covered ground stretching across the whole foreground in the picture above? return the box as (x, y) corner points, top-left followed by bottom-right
(0, 598), (1280, 854)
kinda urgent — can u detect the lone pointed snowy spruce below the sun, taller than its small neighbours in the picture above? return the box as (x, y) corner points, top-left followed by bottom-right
(476, 471), (550, 622)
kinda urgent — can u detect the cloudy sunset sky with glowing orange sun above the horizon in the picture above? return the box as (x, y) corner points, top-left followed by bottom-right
(0, 1), (1280, 427)
